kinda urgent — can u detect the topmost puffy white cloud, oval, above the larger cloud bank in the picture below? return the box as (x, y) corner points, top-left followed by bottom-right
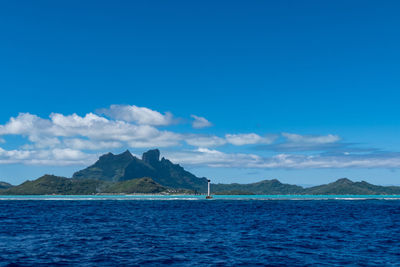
(100, 105), (173, 126)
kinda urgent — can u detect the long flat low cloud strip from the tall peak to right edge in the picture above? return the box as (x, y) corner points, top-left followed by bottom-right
(166, 148), (400, 169)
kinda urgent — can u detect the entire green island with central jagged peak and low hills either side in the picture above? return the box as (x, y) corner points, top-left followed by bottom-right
(0, 149), (400, 195)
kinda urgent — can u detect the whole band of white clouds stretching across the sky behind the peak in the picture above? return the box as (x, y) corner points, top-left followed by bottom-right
(0, 105), (400, 169)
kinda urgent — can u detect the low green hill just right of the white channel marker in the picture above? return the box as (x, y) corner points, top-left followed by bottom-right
(212, 179), (304, 195)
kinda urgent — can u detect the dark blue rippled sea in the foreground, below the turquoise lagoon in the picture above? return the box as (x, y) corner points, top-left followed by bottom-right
(0, 199), (400, 266)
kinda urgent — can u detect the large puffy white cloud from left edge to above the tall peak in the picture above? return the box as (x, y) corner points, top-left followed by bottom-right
(0, 113), (181, 149)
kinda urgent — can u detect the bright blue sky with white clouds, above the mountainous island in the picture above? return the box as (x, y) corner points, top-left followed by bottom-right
(0, 1), (400, 185)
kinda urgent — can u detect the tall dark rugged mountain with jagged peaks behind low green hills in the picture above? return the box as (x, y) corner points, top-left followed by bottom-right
(72, 149), (207, 192)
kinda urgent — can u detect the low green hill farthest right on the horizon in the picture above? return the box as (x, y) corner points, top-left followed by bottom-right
(303, 178), (400, 195)
